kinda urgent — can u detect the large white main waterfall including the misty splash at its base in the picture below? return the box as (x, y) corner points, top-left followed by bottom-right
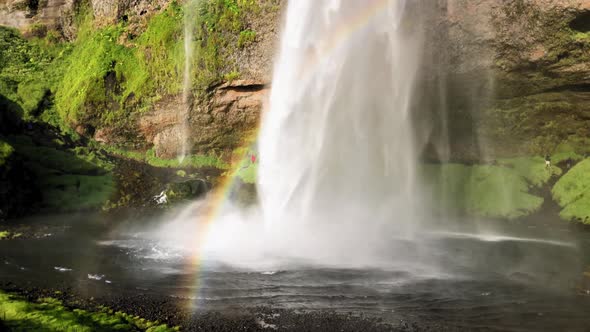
(185, 0), (440, 267)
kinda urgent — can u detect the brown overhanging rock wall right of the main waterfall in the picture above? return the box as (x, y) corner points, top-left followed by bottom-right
(417, 0), (590, 160)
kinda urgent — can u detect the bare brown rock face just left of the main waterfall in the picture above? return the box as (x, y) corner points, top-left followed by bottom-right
(137, 1), (285, 158)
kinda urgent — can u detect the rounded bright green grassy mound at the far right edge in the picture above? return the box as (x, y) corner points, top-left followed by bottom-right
(551, 159), (590, 224)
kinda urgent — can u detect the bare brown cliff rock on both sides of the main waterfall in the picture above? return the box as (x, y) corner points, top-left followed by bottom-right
(0, 0), (590, 159)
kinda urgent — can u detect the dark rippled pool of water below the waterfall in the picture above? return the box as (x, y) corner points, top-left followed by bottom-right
(0, 215), (590, 331)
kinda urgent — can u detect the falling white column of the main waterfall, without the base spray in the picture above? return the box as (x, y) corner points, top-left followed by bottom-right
(258, 0), (422, 232)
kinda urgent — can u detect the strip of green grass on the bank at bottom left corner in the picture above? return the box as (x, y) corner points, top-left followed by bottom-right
(0, 292), (178, 332)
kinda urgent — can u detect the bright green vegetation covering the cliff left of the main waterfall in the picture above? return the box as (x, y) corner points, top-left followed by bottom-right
(0, 0), (273, 217)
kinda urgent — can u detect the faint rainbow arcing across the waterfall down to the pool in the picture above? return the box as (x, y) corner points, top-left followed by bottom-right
(186, 0), (401, 304)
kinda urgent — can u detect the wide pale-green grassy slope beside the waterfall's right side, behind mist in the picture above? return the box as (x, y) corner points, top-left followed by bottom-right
(424, 160), (543, 219)
